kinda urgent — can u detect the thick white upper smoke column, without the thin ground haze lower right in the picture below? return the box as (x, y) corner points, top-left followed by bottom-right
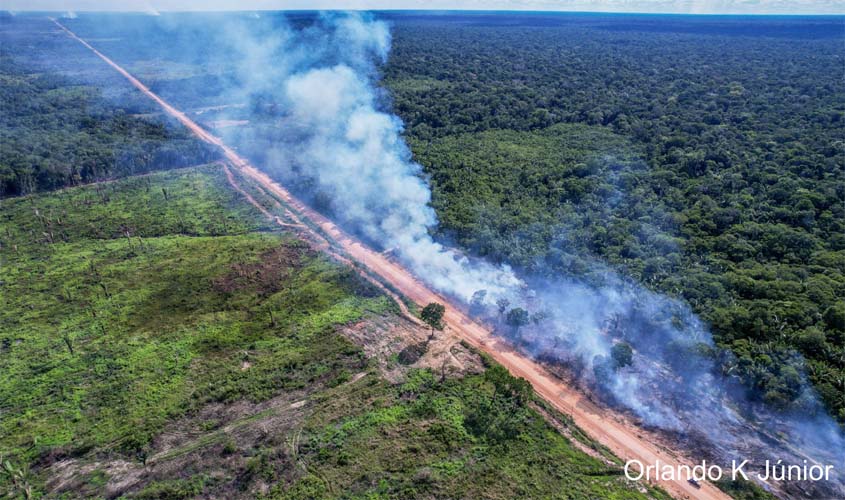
(214, 13), (522, 301)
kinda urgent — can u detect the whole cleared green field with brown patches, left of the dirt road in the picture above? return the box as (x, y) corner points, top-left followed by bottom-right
(0, 165), (665, 499)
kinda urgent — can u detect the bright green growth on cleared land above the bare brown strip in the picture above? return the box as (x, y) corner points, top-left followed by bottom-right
(0, 166), (390, 486)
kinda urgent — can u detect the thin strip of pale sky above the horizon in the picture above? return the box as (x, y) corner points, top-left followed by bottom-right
(0, 0), (845, 14)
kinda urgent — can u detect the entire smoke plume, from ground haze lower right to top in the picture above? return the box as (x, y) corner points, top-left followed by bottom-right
(127, 14), (845, 496)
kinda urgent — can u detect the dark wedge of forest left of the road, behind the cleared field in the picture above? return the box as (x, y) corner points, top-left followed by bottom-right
(0, 54), (217, 197)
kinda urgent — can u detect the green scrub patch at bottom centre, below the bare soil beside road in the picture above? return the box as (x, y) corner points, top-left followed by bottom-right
(269, 366), (666, 499)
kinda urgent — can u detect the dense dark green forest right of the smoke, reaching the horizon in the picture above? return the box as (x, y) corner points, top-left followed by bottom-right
(383, 15), (845, 421)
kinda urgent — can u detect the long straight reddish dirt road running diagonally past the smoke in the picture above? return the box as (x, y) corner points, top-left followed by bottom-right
(53, 19), (730, 500)
